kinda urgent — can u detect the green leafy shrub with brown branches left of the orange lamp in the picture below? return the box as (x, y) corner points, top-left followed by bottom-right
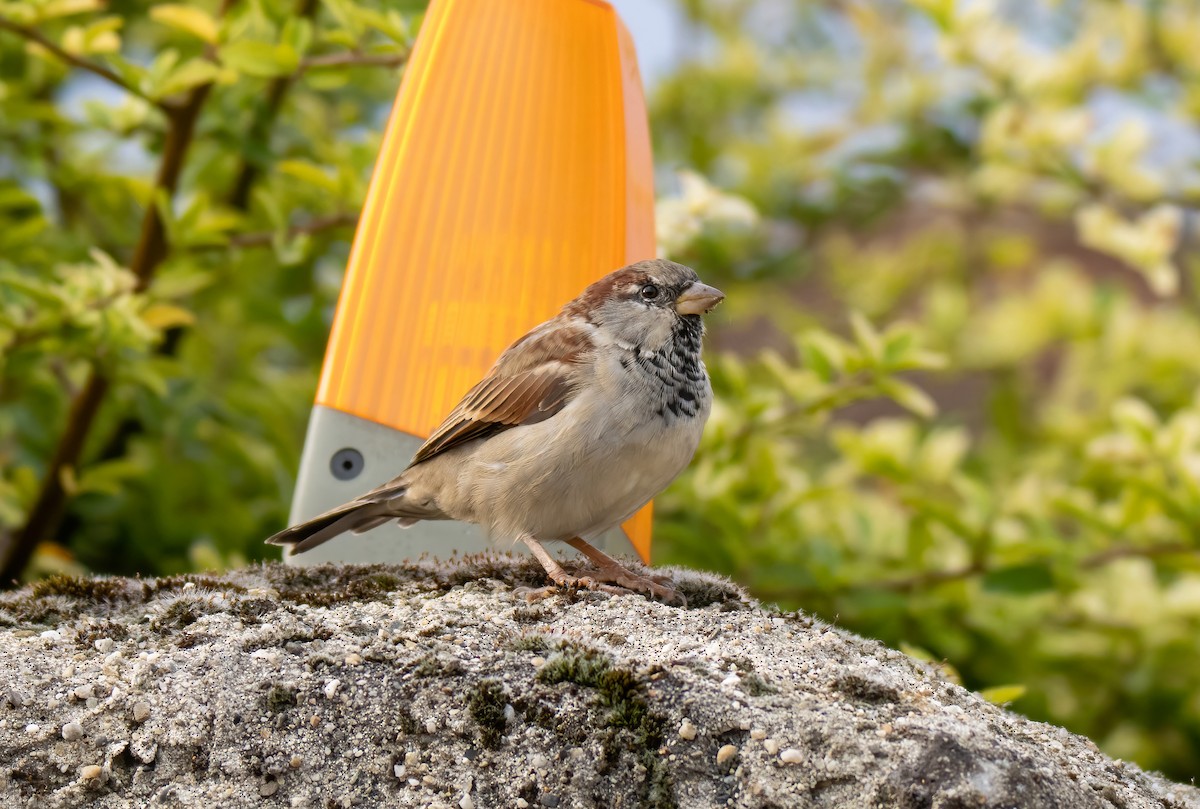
(0, 0), (419, 574)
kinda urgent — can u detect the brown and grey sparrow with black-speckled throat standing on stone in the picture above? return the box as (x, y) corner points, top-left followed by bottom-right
(266, 259), (725, 600)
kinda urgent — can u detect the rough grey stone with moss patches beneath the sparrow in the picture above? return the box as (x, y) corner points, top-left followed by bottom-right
(0, 557), (1200, 809)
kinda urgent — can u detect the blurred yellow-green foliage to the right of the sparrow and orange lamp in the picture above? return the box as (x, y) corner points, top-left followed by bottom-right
(653, 0), (1200, 780)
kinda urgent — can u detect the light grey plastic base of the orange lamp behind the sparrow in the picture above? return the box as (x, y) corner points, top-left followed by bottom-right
(283, 405), (636, 565)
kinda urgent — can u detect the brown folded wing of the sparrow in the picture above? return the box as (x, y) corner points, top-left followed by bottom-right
(409, 318), (593, 466)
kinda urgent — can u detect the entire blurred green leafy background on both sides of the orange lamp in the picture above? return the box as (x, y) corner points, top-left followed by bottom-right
(0, 0), (1200, 780)
